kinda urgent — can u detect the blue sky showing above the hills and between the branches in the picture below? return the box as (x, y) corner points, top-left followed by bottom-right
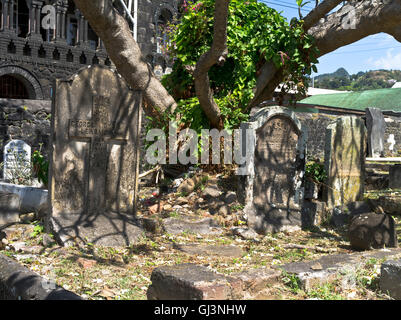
(259, 0), (401, 76)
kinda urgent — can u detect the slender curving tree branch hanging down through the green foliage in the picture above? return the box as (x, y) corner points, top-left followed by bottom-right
(194, 0), (230, 128)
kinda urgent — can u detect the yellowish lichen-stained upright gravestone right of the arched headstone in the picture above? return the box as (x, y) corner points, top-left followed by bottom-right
(325, 116), (367, 208)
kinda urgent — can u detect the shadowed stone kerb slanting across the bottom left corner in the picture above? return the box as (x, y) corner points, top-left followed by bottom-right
(0, 254), (84, 300)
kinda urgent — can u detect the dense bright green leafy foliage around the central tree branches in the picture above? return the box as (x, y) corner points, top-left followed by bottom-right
(162, 0), (317, 132)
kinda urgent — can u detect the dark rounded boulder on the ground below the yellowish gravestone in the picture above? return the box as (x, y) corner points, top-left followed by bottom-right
(349, 213), (398, 250)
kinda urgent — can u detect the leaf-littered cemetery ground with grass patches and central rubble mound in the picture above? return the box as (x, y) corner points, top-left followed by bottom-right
(0, 170), (401, 300)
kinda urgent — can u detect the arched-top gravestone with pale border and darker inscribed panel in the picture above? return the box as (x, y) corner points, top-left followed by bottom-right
(241, 107), (306, 234)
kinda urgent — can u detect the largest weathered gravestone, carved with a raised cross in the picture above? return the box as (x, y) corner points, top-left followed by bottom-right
(49, 66), (142, 246)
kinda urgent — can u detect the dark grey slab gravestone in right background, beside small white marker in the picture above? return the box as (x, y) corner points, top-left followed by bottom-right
(366, 108), (386, 157)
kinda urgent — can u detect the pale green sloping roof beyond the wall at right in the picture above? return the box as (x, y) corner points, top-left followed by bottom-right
(299, 88), (401, 112)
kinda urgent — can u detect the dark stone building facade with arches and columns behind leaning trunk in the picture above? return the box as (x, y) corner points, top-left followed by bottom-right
(0, 0), (178, 100)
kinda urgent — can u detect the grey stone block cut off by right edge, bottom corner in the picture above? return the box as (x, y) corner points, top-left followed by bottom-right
(380, 260), (401, 300)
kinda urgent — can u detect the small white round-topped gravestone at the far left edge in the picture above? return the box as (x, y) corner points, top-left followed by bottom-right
(3, 140), (31, 182)
